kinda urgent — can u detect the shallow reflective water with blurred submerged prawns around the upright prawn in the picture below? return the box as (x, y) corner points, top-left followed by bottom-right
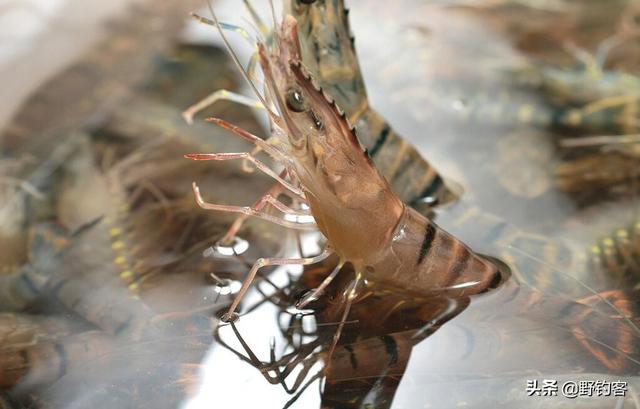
(0, 0), (640, 409)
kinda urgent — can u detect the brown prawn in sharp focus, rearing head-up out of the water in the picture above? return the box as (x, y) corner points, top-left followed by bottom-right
(187, 8), (500, 321)
